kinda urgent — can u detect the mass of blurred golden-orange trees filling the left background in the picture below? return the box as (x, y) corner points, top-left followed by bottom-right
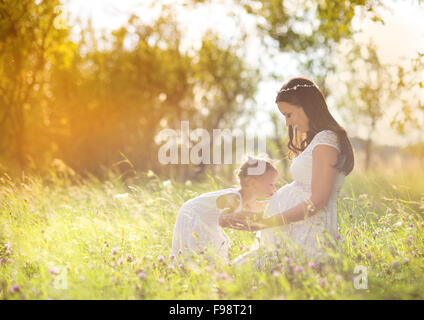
(0, 0), (259, 175)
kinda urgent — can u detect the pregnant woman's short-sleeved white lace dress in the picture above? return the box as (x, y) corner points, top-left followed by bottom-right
(234, 130), (345, 263)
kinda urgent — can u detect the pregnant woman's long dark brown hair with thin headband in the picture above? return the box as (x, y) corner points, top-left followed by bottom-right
(275, 77), (354, 176)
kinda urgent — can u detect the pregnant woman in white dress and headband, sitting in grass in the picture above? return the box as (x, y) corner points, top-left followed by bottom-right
(222, 77), (354, 263)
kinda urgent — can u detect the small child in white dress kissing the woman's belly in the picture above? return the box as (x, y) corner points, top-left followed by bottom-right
(172, 157), (277, 262)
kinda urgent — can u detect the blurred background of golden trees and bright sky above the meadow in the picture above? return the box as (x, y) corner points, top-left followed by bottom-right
(0, 0), (424, 181)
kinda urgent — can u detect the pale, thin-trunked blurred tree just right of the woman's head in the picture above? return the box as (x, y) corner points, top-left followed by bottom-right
(334, 41), (422, 169)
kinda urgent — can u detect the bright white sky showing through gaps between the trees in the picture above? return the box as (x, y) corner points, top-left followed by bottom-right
(60, 0), (424, 144)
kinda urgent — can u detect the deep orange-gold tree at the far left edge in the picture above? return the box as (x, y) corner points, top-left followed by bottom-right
(0, 0), (67, 169)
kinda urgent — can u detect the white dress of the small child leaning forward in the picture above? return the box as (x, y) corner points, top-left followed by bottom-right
(172, 188), (242, 261)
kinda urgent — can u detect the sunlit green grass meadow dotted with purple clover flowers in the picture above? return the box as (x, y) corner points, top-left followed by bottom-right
(0, 169), (424, 299)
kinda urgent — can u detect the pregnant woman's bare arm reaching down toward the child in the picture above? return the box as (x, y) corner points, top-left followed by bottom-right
(260, 145), (338, 228)
